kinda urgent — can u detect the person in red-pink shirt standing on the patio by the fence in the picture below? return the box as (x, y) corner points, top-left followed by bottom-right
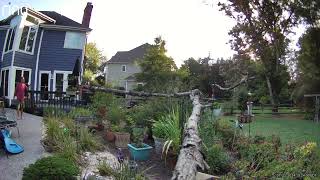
(14, 77), (28, 119)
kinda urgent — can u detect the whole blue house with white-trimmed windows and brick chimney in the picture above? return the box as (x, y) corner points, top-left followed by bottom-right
(0, 3), (93, 103)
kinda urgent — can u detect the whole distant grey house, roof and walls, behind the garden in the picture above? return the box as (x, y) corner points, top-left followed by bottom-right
(105, 43), (151, 90)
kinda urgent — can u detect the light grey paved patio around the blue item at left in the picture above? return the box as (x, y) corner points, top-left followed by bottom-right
(0, 109), (44, 180)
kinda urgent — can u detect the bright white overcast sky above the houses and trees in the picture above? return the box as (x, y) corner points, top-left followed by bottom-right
(0, 0), (234, 66)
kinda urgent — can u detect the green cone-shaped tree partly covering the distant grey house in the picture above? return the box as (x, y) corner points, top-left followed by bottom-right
(136, 37), (177, 92)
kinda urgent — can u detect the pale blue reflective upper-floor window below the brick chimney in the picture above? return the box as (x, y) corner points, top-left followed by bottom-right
(64, 32), (85, 49)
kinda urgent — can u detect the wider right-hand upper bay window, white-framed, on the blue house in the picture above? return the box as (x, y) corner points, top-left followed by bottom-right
(19, 26), (37, 53)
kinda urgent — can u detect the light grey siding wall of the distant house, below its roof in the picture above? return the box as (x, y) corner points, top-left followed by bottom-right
(107, 63), (141, 88)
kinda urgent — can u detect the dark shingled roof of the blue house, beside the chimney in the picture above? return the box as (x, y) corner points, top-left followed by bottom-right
(39, 11), (82, 27)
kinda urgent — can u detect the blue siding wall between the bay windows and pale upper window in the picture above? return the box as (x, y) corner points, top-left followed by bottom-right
(38, 30), (82, 72)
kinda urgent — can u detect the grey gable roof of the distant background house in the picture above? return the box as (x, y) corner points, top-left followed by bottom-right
(107, 43), (152, 64)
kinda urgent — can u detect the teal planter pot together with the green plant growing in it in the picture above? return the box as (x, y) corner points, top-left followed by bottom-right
(128, 128), (152, 161)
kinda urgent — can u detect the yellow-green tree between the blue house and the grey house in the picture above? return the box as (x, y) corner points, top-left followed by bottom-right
(84, 43), (107, 84)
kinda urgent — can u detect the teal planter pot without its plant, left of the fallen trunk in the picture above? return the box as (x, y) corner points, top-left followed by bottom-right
(128, 143), (152, 161)
